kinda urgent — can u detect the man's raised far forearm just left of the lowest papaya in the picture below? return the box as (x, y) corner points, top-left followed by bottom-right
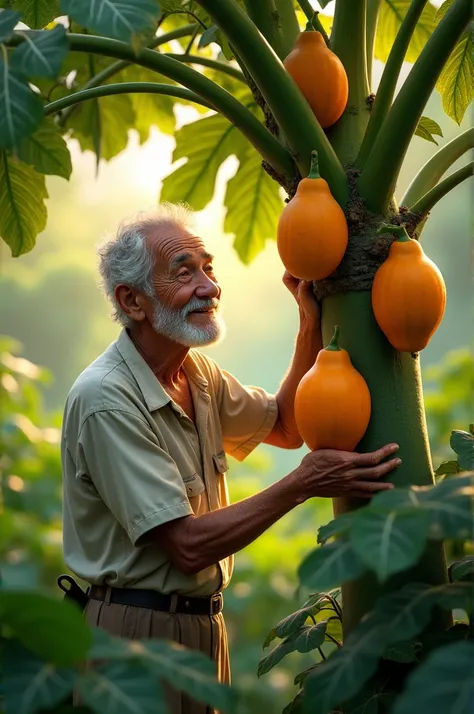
(265, 324), (322, 448)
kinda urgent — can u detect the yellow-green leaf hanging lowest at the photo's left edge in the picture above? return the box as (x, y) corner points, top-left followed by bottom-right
(0, 151), (48, 257)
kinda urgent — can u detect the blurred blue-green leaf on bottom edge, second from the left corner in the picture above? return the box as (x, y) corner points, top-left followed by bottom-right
(77, 662), (167, 714)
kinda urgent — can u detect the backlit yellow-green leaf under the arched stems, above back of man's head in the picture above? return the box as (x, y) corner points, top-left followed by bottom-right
(69, 94), (135, 161)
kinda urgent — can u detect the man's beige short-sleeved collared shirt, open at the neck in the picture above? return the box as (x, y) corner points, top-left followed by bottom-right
(61, 330), (277, 596)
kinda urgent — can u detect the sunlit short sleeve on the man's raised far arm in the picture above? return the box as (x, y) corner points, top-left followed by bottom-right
(219, 370), (278, 461)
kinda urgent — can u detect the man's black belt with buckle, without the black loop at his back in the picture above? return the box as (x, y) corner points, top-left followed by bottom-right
(88, 585), (223, 615)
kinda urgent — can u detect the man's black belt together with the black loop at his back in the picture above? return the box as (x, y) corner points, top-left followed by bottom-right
(58, 575), (223, 615)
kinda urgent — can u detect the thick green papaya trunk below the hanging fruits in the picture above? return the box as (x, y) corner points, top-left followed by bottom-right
(323, 291), (451, 635)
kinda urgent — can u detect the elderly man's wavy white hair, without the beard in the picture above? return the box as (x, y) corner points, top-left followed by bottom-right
(97, 203), (193, 327)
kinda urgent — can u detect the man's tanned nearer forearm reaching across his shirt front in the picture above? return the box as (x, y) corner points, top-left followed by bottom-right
(163, 472), (304, 573)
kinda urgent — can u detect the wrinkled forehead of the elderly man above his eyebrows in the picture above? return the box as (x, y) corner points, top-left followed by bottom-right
(147, 223), (212, 271)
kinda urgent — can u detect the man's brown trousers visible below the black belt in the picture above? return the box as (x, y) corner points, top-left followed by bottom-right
(85, 600), (230, 714)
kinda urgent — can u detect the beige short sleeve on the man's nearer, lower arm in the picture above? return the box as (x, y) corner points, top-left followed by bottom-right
(78, 409), (193, 545)
